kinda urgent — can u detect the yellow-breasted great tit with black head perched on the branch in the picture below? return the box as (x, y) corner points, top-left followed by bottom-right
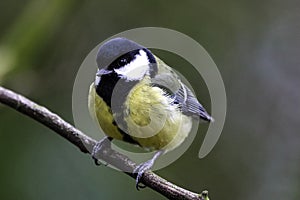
(88, 38), (213, 189)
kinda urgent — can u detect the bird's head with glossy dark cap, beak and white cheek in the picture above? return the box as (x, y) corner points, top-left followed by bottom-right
(96, 38), (157, 85)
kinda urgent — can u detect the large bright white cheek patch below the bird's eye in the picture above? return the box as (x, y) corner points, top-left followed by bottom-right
(114, 50), (150, 81)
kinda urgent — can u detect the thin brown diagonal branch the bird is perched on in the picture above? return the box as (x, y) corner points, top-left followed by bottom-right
(0, 86), (208, 200)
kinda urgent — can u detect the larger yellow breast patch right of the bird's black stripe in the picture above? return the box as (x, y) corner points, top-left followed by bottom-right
(125, 76), (192, 150)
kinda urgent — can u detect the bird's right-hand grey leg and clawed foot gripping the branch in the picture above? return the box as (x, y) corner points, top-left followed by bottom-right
(133, 150), (165, 190)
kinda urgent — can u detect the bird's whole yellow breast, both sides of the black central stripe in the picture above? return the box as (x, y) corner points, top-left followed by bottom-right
(89, 77), (192, 150)
